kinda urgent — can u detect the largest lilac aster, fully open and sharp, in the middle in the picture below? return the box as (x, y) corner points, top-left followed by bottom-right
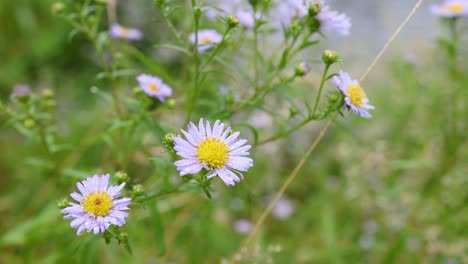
(174, 118), (253, 185)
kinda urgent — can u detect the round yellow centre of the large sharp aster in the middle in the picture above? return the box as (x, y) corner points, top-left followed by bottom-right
(197, 137), (229, 169)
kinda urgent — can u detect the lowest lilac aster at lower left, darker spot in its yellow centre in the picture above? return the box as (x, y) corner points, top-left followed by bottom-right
(62, 174), (130, 236)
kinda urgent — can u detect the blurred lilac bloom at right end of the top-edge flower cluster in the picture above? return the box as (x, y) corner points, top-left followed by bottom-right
(316, 1), (351, 36)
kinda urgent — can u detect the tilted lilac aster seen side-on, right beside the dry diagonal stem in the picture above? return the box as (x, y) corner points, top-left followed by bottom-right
(332, 71), (374, 118)
